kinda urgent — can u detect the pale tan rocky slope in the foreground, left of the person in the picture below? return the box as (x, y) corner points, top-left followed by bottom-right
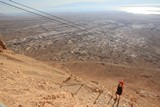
(0, 40), (127, 107)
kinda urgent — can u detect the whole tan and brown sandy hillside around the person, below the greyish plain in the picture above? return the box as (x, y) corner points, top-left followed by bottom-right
(0, 38), (160, 107)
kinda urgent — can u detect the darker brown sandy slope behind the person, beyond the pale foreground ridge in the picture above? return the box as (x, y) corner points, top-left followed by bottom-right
(62, 62), (160, 107)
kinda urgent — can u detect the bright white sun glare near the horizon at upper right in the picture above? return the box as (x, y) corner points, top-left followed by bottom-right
(119, 7), (160, 14)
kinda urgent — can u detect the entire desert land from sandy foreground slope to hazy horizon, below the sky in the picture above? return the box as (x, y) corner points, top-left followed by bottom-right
(0, 12), (160, 107)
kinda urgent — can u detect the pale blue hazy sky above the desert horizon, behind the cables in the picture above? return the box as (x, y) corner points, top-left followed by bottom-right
(0, 0), (160, 14)
